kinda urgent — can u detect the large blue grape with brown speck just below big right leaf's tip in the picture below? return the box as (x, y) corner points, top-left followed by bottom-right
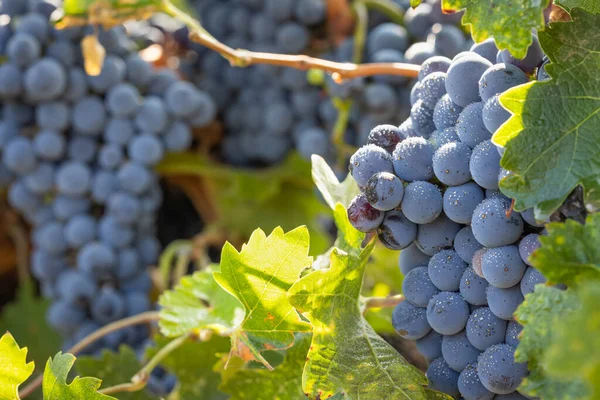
(471, 198), (523, 247)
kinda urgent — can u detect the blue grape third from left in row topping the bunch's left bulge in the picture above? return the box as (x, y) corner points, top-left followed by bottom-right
(433, 142), (471, 186)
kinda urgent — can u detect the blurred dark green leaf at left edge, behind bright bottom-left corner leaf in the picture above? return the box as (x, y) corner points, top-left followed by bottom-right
(0, 282), (61, 373)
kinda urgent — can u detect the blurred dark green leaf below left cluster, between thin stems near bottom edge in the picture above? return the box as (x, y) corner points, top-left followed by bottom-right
(75, 345), (158, 400)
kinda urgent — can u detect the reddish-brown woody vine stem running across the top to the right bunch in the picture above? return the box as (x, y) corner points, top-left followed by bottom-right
(162, 0), (421, 83)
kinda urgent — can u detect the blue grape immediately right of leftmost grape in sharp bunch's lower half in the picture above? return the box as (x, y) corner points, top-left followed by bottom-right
(427, 292), (469, 335)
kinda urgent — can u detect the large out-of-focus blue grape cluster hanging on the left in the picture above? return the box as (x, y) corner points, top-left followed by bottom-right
(0, 0), (216, 352)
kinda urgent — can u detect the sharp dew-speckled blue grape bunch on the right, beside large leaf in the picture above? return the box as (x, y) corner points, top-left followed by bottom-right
(348, 37), (548, 400)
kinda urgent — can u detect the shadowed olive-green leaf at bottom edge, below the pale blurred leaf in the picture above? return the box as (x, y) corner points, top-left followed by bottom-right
(146, 335), (229, 400)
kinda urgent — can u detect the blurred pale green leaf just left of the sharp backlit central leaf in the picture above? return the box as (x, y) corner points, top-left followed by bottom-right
(158, 270), (244, 337)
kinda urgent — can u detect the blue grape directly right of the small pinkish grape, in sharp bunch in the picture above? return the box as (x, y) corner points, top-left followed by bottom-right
(481, 245), (526, 289)
